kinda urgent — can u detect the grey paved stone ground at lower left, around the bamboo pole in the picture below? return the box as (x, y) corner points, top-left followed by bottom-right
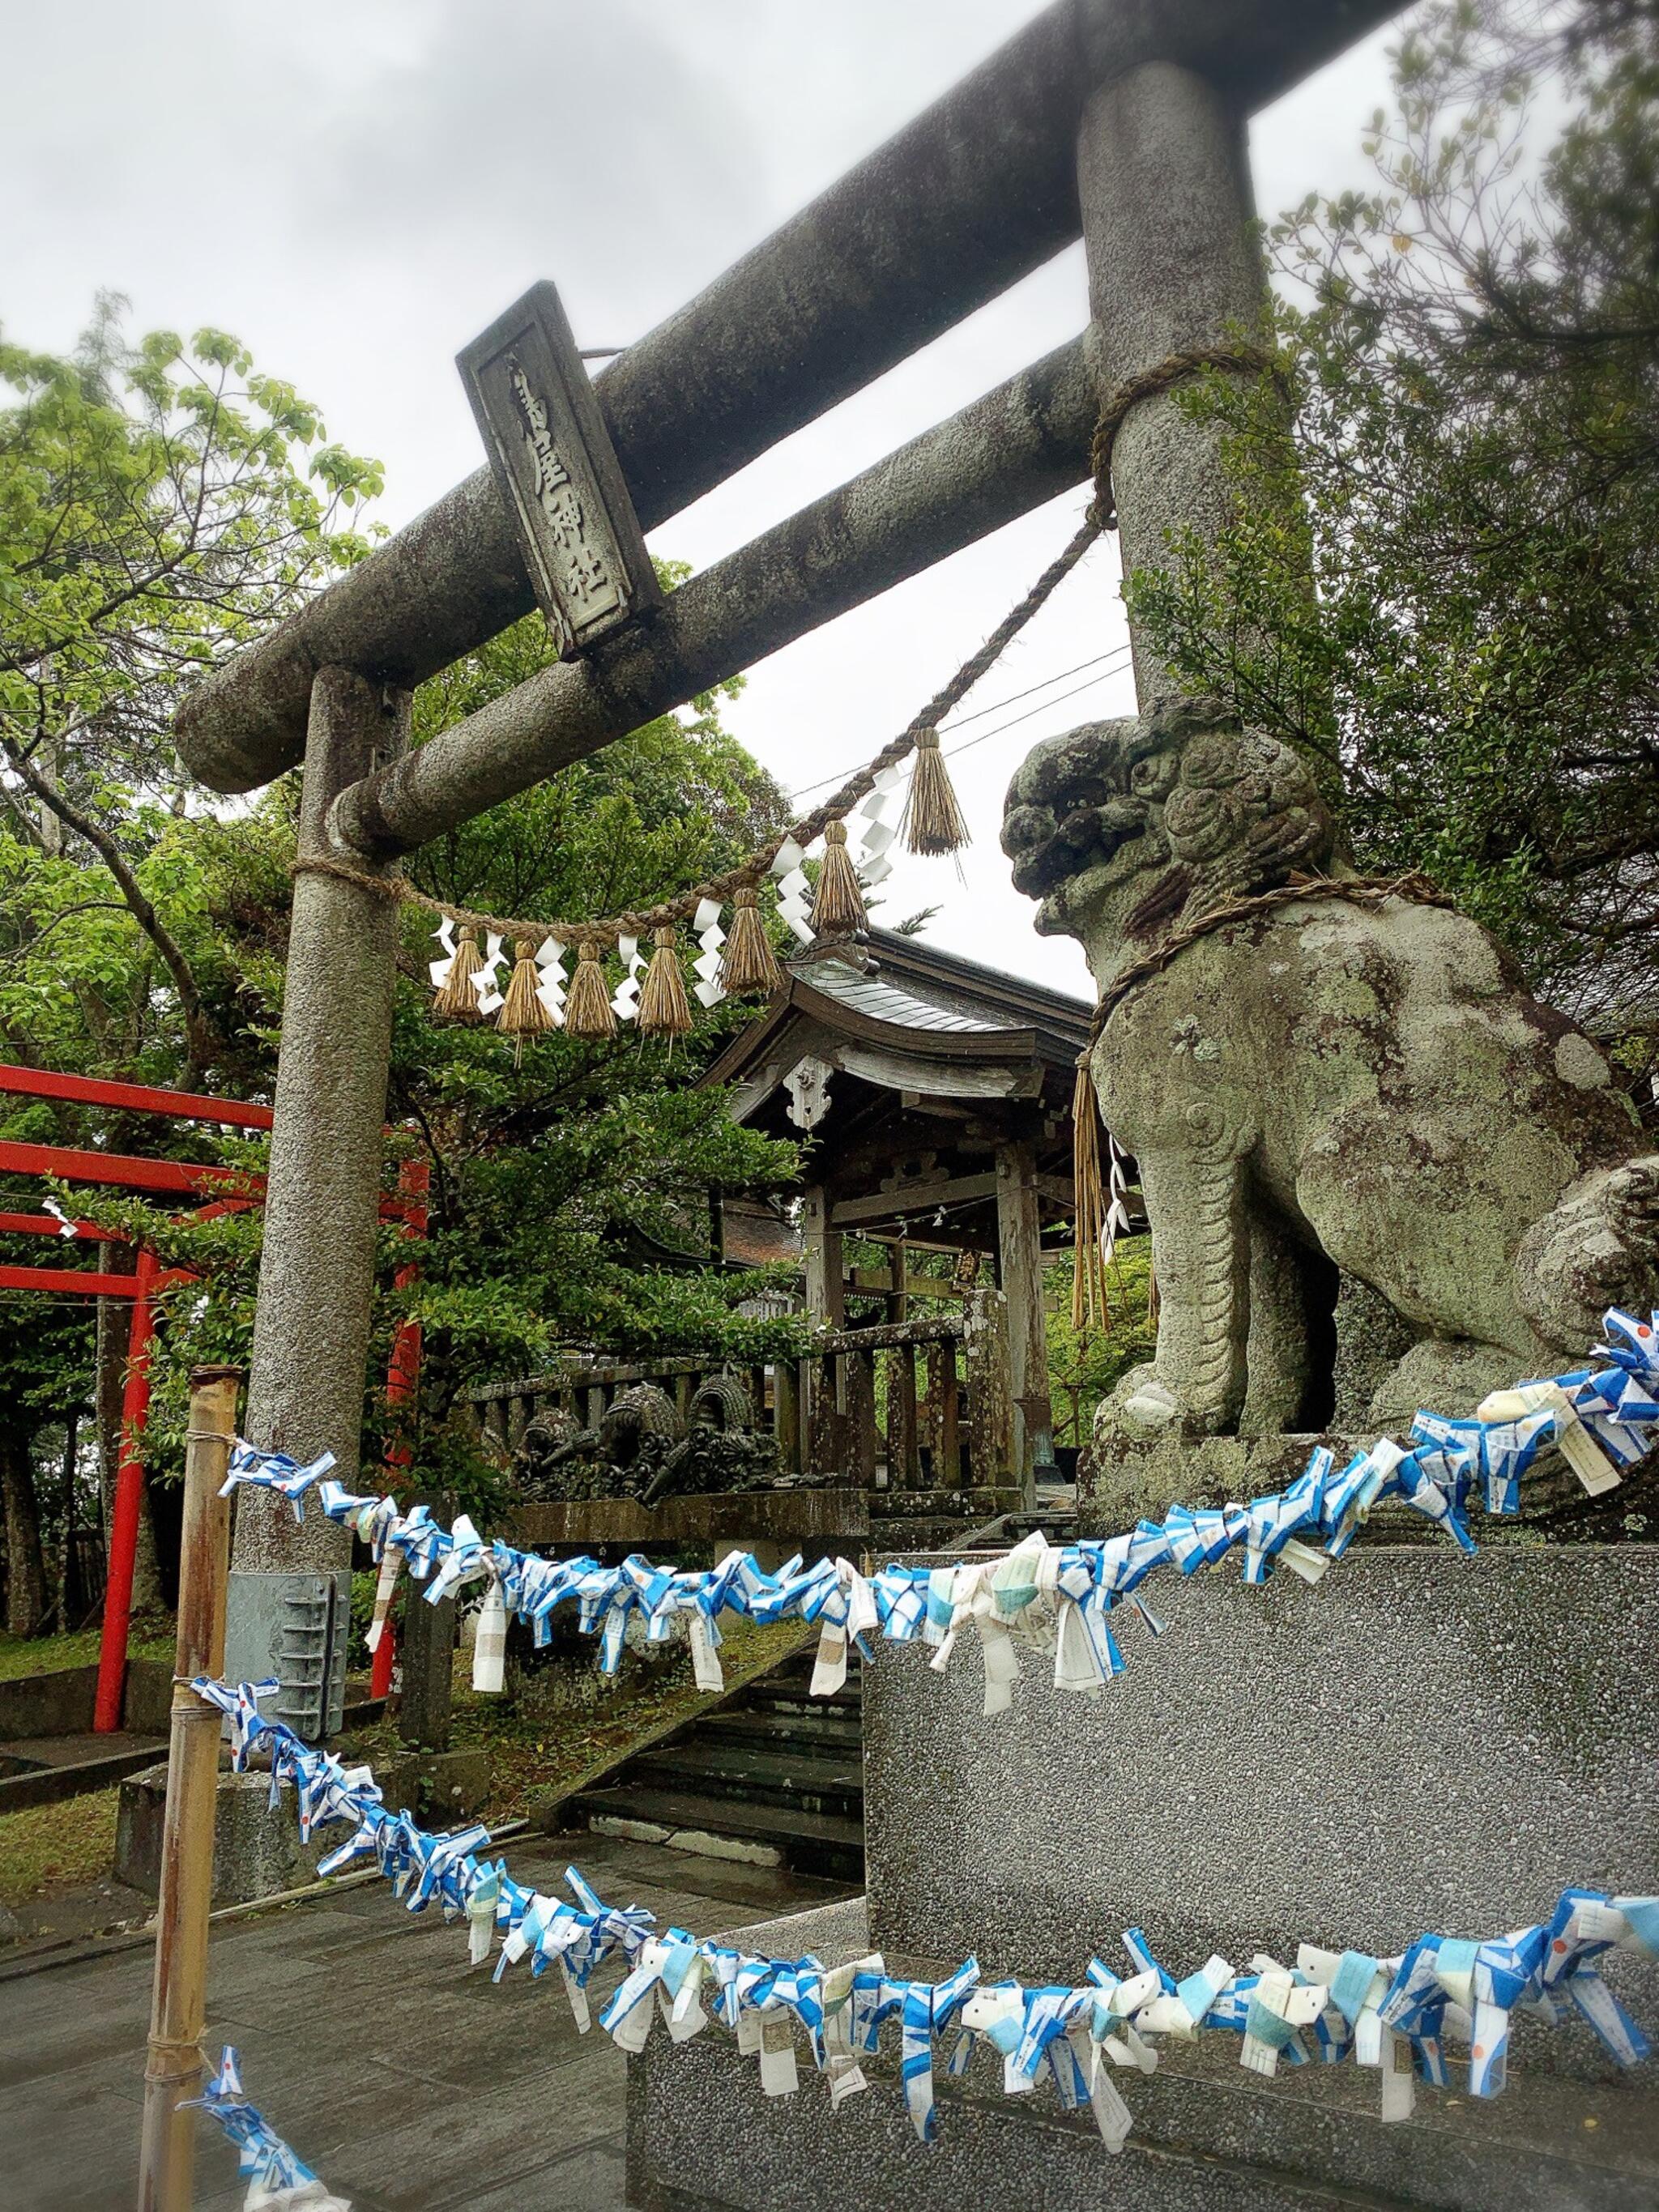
(0, 1836), (847, 2212)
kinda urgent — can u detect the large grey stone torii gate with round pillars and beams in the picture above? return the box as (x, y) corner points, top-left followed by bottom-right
(177, 0), (1398, 1707)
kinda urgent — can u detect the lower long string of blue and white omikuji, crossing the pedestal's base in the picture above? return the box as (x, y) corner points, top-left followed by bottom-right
(193, 1674), (1659, 2150)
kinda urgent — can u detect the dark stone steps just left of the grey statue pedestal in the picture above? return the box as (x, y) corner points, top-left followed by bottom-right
(562, 1652), (865, 1882)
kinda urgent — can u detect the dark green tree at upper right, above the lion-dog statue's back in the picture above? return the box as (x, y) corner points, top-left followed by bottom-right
(1132, 0), (1659, 1066)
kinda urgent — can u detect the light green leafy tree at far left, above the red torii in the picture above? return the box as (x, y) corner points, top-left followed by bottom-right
(0, 294), (381, 1081)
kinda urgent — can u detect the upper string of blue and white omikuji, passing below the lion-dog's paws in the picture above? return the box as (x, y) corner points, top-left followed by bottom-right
(224, 1307), (1659, 1712)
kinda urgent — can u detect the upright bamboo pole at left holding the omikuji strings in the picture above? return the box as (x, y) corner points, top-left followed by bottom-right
(139, 1367), (241, 2212)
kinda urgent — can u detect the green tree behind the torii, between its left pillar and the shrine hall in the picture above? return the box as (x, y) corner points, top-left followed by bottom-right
(362, 615), (813, 1489)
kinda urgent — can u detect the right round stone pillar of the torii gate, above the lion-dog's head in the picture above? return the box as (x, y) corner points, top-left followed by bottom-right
(1077, 62), (1268, 710)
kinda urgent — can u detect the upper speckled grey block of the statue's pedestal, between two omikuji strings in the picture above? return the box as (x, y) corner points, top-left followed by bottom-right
(865, 1544), (1659, 2008)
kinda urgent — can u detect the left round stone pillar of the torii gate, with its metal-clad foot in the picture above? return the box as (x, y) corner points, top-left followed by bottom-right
(226, 668), (409, 1737)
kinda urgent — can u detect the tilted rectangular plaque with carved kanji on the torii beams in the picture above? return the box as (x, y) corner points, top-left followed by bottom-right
(458, 283), (661, 657)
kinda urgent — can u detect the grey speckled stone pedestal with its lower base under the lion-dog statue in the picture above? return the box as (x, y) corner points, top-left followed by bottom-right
(629, 1546), (1659, 2212)
